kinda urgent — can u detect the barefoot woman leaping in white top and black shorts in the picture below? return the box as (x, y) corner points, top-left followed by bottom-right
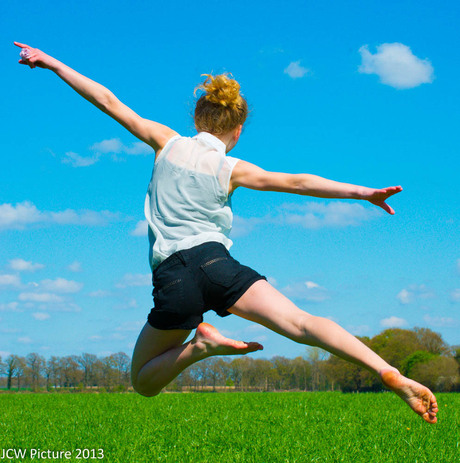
(15, 42), (438, 423)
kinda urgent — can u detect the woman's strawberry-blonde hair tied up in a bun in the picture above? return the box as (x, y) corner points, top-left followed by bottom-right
(194, 73), (248, 135)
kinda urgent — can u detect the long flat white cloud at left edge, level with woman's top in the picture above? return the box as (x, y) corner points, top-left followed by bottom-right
(0, 201), (122, 230)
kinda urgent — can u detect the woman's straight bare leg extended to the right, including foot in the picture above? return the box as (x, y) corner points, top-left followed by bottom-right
(228, 280), (438, 423)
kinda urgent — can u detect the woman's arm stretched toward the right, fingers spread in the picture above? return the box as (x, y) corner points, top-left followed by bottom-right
(229, 160), (402, 214)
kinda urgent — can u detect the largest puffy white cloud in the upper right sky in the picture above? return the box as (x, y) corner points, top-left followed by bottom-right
(358, 43), (434, 89)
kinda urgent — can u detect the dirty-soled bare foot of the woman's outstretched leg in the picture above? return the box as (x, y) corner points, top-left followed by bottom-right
(380, 370), (438, 424)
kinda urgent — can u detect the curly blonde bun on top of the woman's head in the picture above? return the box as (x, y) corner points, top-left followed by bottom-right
(195, 74), (242, 108)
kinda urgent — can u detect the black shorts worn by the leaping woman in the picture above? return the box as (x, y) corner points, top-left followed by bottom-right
(147, 241), (266, 330)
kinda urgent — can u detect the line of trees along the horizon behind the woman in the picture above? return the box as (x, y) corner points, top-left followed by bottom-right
(0, 328), (460, 392)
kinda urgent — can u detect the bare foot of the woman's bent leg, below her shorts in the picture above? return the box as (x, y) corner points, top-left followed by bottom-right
(192, 323), (263, 357)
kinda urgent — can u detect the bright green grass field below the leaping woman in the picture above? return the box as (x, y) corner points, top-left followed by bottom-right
(0, 392), (460, 463)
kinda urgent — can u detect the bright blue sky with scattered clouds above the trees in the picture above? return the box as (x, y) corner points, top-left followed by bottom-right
(0, 1), (460, 358)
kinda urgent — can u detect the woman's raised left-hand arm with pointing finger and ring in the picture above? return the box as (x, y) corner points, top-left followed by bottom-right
(14, 42), (177, 151)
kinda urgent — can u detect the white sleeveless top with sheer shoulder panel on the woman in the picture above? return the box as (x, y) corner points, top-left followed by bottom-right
(145, 132), (239, 270)
